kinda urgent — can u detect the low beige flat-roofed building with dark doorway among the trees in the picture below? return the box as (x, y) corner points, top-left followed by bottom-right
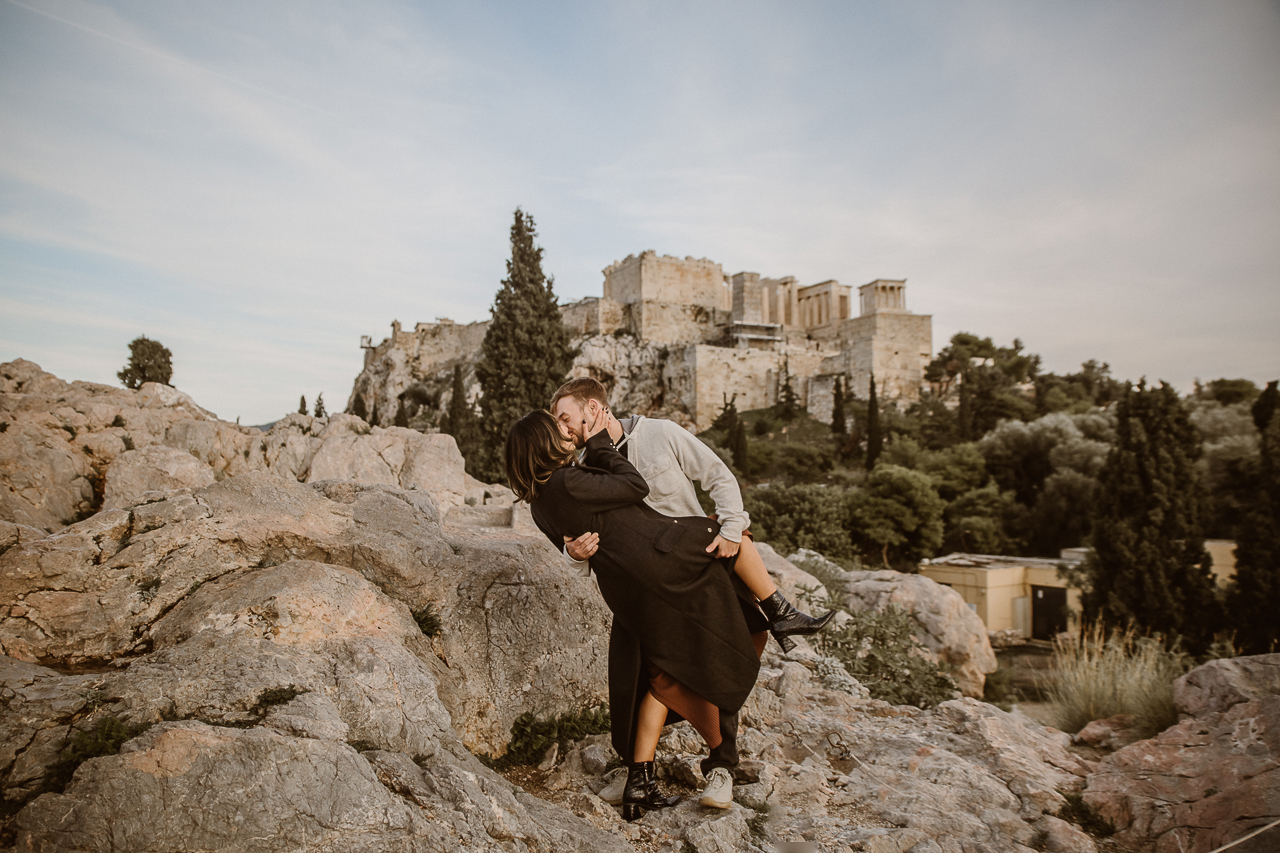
(920, 553), (1080, 640)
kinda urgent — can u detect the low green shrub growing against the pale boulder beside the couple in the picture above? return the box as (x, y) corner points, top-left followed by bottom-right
(800, 590), (956, 708)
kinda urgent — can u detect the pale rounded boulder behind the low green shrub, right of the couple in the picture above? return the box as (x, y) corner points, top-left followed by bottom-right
(790, 551), (997, 698)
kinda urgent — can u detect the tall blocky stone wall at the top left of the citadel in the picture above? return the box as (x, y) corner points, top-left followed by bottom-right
(604, 250), (731, 311)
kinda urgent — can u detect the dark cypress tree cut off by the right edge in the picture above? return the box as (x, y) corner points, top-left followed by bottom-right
(1228, 404), (1280, 654)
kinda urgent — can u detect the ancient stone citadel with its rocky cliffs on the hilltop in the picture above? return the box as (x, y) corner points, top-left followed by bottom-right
(347, 251), (933, 429)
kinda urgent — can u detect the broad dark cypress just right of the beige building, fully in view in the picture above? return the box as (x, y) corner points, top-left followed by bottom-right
(1083, 380), (1219, 652)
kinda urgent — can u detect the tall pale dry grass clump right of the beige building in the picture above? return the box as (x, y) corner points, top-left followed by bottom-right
(1046, 625), (1189, 738)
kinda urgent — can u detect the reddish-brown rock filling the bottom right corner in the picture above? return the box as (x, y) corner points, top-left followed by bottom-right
(1084, 654), (1280, 853)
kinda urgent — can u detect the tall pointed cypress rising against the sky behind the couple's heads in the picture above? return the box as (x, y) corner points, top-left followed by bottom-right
(467, 207), (575, 483)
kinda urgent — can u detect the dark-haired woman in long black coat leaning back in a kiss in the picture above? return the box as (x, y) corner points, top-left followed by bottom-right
(506, 411), (768, 820)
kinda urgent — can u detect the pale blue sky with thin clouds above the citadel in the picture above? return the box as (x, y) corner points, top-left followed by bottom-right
(0, 0), (1280, 424)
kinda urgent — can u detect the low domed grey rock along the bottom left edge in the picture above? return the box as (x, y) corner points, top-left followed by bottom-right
(18, 721), (627, 853)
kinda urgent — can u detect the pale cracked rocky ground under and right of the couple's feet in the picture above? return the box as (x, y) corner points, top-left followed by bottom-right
(537, 652), (1096, 853)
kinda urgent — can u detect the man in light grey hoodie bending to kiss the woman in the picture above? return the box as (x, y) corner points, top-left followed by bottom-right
(550, 377), (835, 808)
